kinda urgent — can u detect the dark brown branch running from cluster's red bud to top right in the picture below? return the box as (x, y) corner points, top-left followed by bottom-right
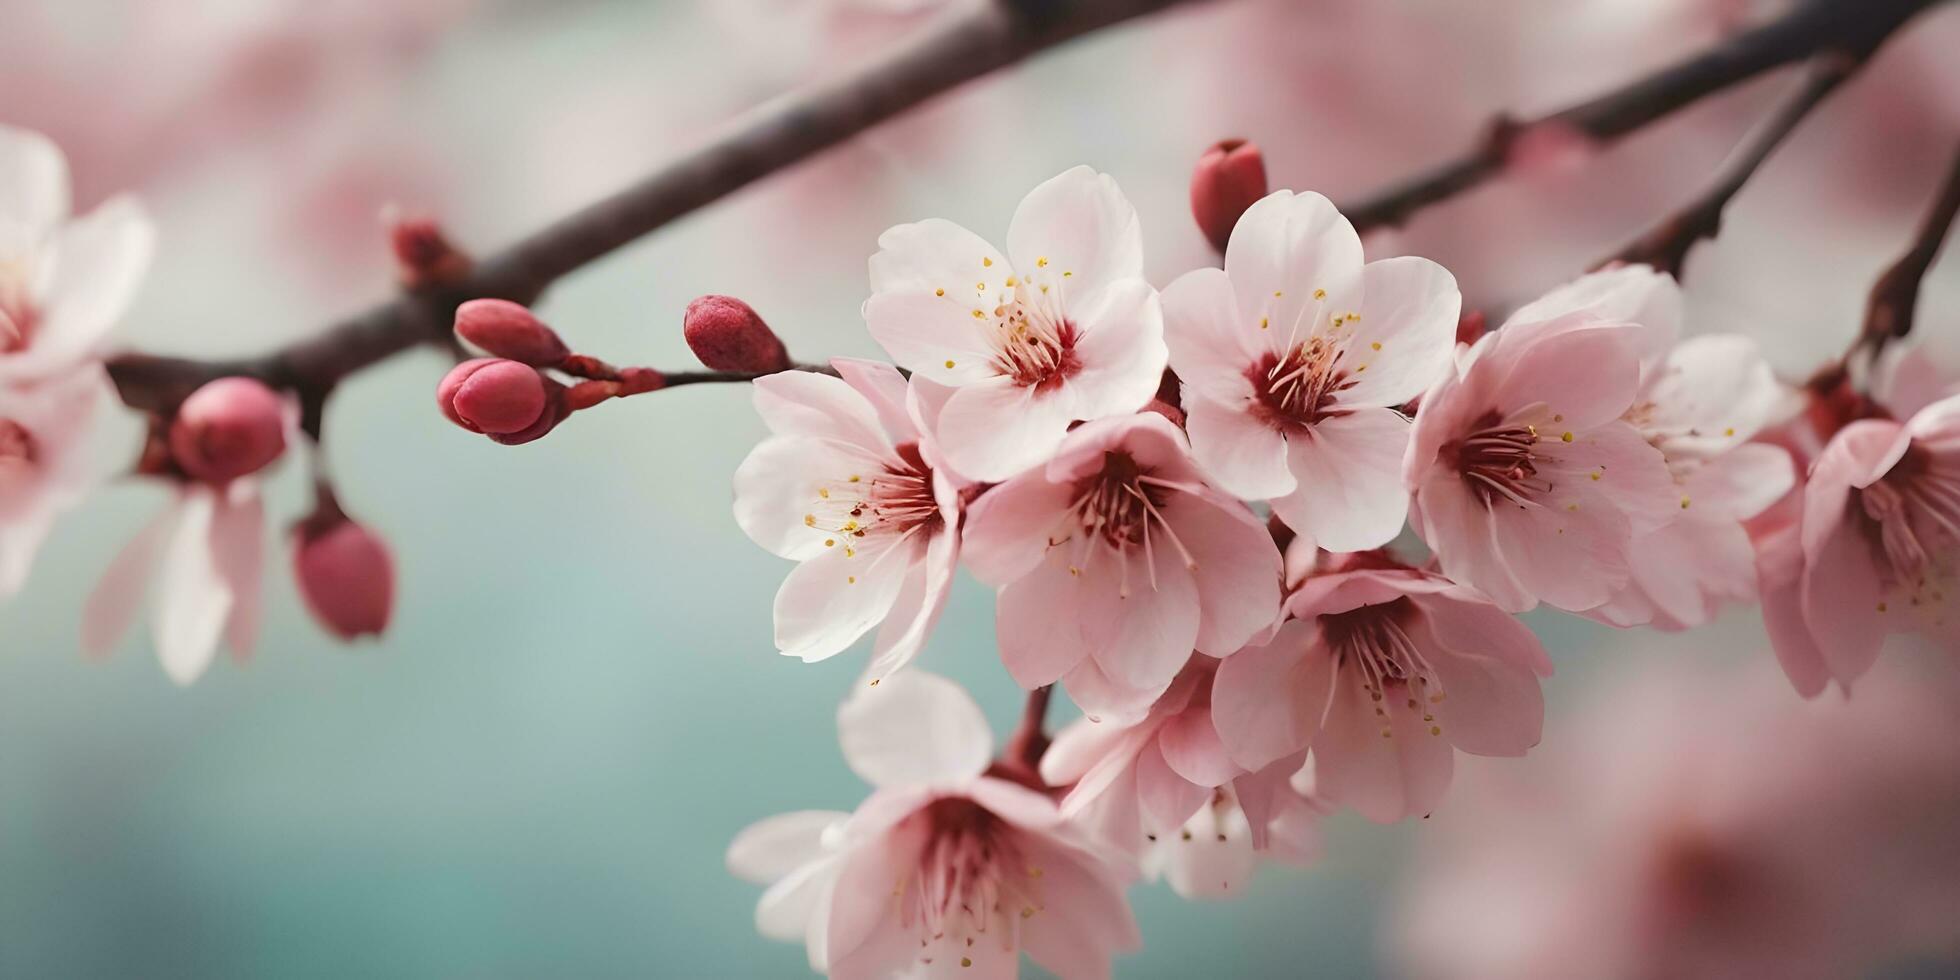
(1341, 0), (1944, 231)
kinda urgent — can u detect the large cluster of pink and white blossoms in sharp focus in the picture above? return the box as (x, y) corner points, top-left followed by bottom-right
(729, 164), (1960, 978)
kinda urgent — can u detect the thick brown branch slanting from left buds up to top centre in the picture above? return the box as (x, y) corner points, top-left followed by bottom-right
(108, 0), (1190, 412)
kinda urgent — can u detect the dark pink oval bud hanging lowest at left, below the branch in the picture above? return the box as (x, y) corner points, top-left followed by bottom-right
(292, 514), (394, 639)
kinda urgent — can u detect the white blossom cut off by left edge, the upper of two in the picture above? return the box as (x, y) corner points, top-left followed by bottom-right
(0, 125), (155, 380)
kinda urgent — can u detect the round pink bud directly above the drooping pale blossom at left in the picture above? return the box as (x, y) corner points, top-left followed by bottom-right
(171, 378), (286, 484)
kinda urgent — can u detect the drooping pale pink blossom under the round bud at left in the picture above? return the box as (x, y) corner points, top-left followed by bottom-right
(82, 478), (265, 684)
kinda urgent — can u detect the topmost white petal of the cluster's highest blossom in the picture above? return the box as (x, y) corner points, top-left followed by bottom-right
(1007, 167), (1143, 292)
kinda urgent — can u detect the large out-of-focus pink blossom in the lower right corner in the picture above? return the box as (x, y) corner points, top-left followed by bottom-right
(1384, 659), (1960, 980)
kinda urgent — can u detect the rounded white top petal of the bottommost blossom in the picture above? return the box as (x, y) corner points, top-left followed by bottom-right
(837, 670), (994, 788)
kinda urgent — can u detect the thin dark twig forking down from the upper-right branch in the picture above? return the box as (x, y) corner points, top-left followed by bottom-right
(1593, 51), (1866, 278)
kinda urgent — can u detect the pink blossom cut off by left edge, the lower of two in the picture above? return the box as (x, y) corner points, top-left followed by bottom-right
(0, 367), (110, 598)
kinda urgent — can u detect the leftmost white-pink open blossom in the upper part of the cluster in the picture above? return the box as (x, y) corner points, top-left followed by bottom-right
(735, 359), (960, 682)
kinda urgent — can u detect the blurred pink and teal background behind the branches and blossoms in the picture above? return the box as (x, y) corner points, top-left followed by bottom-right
(0, 0), (1960, 978)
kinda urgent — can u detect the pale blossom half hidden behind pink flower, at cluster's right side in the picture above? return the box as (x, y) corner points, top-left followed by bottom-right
(1519, 265), (1795, 629)
